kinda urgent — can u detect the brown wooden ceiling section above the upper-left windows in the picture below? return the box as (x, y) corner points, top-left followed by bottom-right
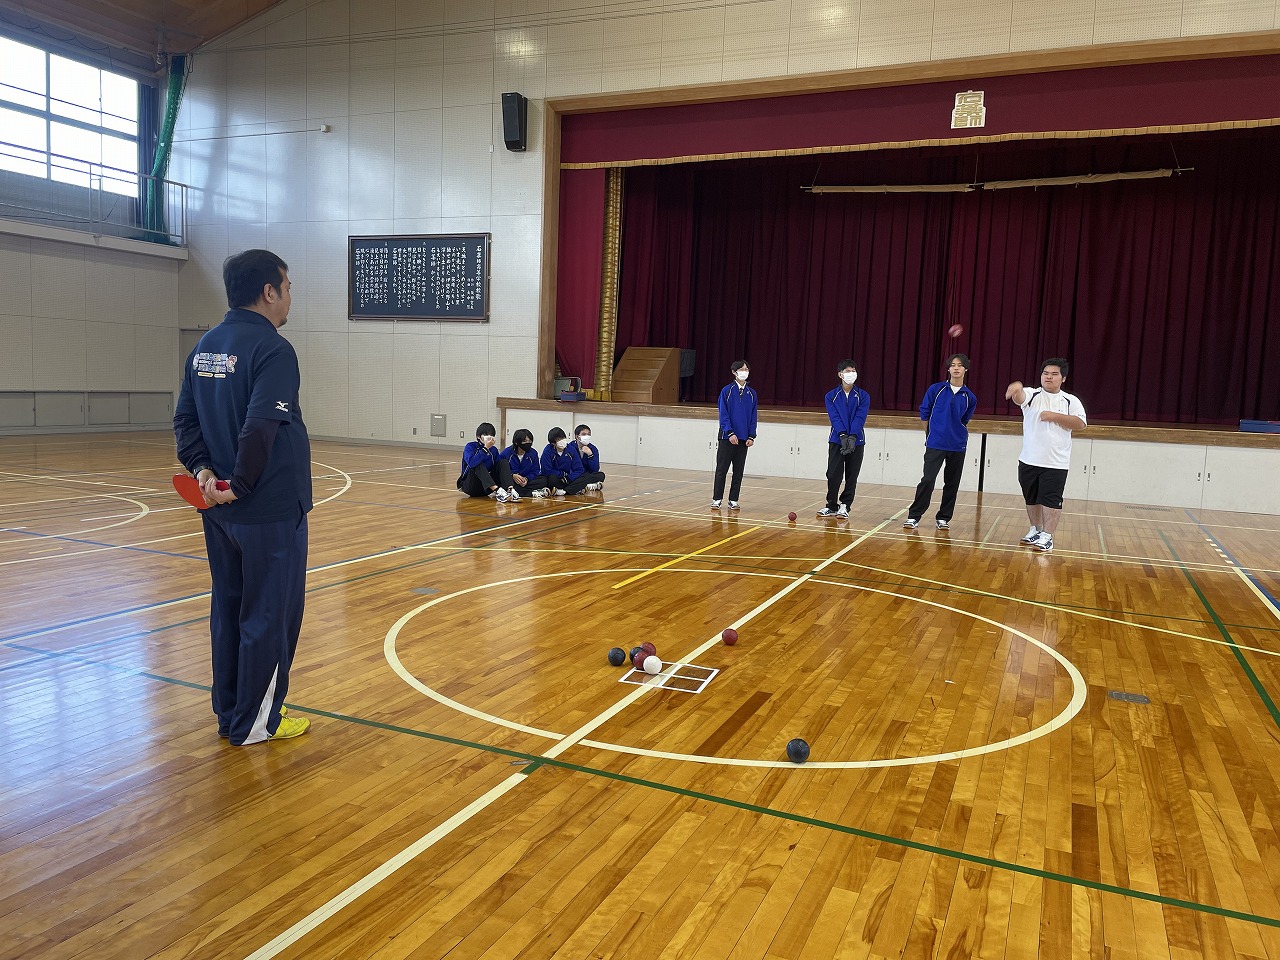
(0, 0), (289, 72)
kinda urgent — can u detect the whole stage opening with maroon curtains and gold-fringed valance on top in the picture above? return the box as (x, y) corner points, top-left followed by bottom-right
(557, 55), (1280, 425)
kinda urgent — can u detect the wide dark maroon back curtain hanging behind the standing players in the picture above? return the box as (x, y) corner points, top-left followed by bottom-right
(617, 131), (1280, 424)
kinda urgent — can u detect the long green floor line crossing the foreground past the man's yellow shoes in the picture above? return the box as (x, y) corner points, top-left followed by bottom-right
(10, 640), (1280, 928)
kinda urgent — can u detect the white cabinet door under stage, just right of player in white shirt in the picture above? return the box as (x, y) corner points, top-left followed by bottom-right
(1085, 440), (1204, 508)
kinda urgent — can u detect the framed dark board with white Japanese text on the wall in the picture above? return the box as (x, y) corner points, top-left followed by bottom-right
(347, 233), (492, 321)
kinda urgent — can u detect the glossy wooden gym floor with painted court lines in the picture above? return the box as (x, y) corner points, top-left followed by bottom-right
(0, 434), (1280, 960)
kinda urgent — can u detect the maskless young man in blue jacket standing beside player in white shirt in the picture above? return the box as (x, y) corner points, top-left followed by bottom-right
(902, 353), (978, 530)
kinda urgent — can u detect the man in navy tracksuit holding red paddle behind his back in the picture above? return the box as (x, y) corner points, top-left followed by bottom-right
(173, 250), (311, 746)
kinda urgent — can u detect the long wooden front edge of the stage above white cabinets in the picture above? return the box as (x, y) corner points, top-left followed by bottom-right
(497, 397), (1280, 451)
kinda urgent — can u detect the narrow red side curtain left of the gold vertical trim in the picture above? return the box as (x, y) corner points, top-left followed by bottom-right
(556, 170), (604, 388)
